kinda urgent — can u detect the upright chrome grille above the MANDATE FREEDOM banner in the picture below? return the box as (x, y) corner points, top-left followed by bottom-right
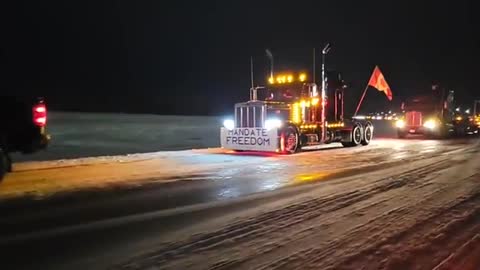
(235, 104), (266, 128)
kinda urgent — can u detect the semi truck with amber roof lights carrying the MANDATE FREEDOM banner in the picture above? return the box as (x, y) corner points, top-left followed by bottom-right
(220, 69), (374, 154)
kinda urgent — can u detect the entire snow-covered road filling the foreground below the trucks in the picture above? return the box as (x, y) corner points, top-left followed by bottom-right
(0, 138), (480, 269)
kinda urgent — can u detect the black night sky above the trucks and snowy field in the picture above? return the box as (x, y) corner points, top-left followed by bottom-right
(0, 0), (480, 115)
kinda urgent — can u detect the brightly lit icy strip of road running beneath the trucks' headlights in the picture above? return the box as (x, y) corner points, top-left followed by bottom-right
(0, 139), (468, 199)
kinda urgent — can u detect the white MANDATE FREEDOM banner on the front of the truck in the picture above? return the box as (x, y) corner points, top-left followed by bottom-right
(220, 128), (279, 152)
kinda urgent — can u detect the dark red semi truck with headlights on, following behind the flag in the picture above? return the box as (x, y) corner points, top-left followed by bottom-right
(395, 87), (479, 138)
